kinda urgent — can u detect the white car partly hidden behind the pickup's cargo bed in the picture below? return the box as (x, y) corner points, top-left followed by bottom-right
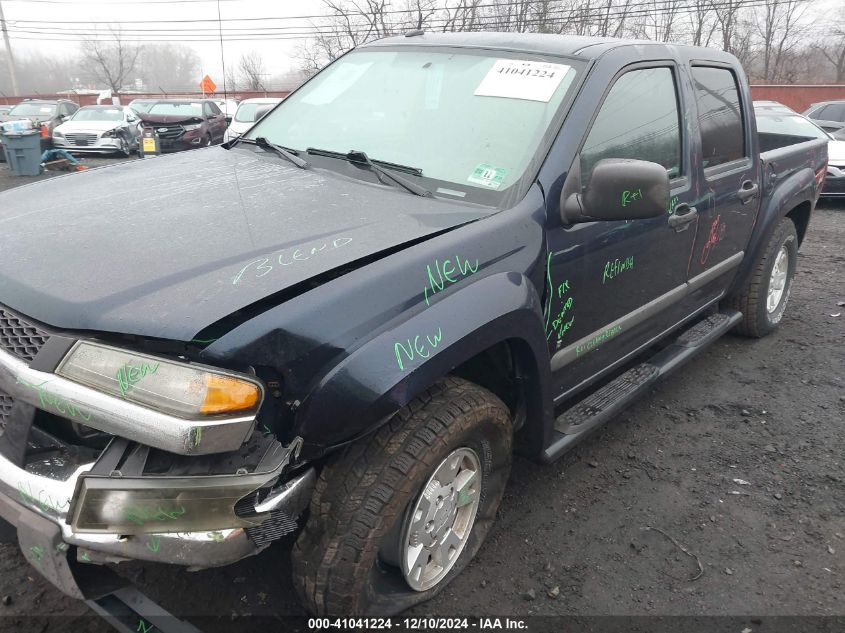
(754, 106), (845, 198)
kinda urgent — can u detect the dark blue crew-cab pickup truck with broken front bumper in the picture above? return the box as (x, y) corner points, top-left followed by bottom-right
(0, 32), (826, 614)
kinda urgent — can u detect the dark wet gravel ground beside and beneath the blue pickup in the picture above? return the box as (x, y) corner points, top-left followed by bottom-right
(0, 159), (845, 633)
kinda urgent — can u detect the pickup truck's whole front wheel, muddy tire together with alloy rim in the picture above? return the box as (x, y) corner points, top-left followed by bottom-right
(293, 377), (512, 616)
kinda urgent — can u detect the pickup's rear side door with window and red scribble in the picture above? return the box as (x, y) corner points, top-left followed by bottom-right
(689, 64), (760, 299)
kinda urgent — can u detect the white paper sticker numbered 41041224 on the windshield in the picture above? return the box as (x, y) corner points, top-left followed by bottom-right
(475, 59), (570, 103)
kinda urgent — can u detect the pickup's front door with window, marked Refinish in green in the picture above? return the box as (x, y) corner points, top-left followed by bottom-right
(544, 62), (695, 393)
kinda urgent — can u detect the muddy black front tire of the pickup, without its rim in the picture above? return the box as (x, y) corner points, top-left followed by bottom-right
(293, 377), (513, 616)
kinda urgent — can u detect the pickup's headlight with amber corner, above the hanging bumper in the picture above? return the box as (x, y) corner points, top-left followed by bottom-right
(56, 342), (262, 418)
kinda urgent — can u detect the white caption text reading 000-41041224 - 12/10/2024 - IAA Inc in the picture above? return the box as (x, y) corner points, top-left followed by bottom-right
(308, 616), (528, 631)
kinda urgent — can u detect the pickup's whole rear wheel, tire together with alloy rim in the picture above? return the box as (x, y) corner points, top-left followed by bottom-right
(726, 218), (798, 338)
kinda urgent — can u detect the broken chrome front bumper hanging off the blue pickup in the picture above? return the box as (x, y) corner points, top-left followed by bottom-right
(0, 434), (315, 597)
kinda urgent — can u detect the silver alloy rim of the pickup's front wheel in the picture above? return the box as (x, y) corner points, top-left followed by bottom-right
(400, 448), (481, 591)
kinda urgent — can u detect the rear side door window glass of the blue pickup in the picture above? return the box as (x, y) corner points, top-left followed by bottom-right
(692, 66), (747, 168)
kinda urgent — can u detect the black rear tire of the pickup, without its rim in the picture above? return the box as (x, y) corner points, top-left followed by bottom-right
(725, 218), (798, 338)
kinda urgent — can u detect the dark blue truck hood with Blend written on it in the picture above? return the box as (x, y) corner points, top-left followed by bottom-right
(0, 147), (493, 341)
